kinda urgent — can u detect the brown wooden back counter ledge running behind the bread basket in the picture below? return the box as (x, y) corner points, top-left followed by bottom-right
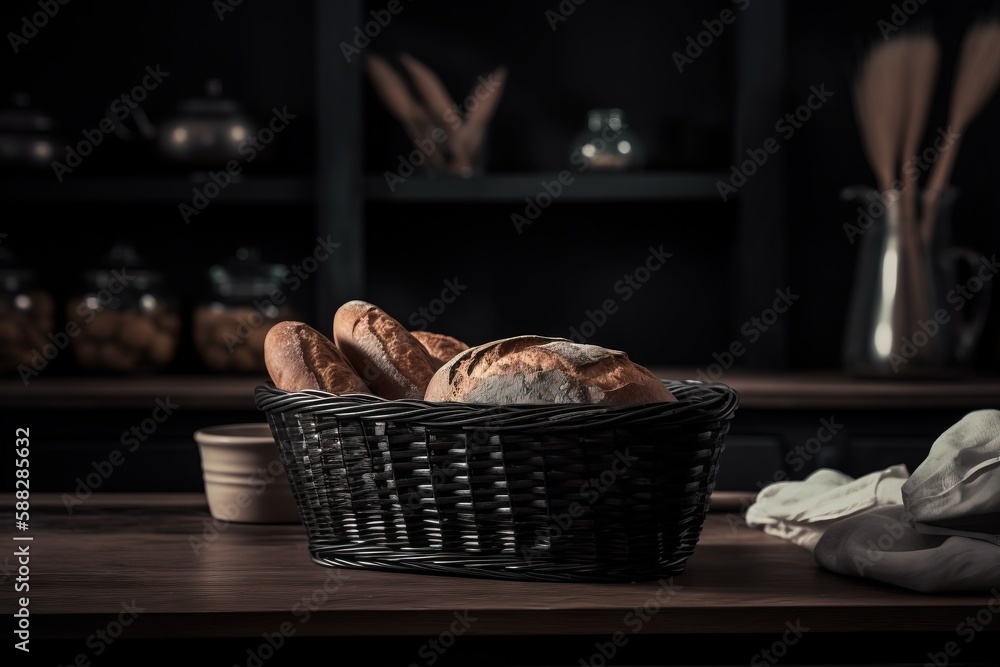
(0, 367), (1000, 410)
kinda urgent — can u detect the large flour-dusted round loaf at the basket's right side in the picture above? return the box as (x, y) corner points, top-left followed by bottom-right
(424, 336), (677, 406)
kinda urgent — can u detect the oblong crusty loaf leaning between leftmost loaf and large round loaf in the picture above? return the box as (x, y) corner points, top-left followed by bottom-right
(333, 300), (438, 400)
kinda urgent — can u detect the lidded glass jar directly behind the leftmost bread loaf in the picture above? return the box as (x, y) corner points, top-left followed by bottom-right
(194, 248), (297, 373)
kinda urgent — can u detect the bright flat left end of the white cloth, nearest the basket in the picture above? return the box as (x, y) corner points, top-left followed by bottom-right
(746, 465), (909, 551)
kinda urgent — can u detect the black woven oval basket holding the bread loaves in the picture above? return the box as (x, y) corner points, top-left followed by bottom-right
(255, 381), (739, 581)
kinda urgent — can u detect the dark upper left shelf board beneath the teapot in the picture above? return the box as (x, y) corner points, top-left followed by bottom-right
(0, 173), (315, 204)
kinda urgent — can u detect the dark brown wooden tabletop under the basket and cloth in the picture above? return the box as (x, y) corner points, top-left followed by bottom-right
(0, 494), (1000, 638)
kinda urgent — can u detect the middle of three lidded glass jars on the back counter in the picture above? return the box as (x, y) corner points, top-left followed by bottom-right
(66, 244), (181, 373)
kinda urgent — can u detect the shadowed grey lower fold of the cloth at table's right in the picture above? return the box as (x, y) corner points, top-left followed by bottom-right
(813, 505), (1000, 593)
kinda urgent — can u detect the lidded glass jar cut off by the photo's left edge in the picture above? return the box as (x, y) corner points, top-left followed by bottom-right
(0, 262), (55, 371)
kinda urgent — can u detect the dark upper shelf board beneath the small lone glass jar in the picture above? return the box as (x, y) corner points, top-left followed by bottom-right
(367, 171), (727, 202)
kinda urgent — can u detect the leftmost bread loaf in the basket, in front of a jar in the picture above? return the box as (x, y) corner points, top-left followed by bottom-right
(264, 321), (371, 394)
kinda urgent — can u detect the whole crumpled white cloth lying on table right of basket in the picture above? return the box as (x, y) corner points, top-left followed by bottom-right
(746, 410), (1000, 593)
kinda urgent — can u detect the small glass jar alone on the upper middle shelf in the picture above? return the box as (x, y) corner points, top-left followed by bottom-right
(570, 109), (645, 171)
